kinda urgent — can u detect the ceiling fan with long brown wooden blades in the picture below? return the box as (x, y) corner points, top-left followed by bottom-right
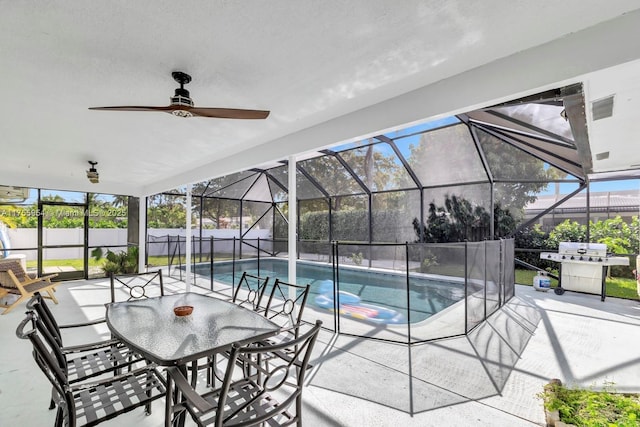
(89, 71), (269, 119)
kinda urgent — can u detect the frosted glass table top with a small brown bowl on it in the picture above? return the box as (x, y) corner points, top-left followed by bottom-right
(106, 293), (279, 366)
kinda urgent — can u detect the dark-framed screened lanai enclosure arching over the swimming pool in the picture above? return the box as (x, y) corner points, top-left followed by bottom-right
(147, 85), (591, 343)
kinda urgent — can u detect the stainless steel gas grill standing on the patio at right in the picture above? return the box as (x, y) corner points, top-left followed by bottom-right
(540, 242), (629, 301)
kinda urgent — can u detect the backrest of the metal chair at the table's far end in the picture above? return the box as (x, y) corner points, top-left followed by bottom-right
(109, 270), (164, 302)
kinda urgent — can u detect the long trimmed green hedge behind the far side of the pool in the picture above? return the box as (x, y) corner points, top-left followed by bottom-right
(299, 210), (417, 243)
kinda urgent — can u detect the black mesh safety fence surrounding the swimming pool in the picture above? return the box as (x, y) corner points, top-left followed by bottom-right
(147, 236), (515, 344)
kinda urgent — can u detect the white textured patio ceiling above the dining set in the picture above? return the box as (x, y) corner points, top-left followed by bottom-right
(0, 0), (640, 196)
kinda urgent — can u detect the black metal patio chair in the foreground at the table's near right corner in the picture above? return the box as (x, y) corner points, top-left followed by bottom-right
(165, 320), (322, 427)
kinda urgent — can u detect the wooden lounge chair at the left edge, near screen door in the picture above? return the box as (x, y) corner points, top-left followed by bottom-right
(0, 259), (58, 314)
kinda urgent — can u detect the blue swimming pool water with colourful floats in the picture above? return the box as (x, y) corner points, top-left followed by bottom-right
(195, 259), (464, 323)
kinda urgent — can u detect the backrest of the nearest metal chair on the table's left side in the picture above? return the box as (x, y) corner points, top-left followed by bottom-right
(16, 311), (73, 413)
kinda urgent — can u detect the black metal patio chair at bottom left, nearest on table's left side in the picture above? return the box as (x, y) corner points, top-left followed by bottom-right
(16, 311), (166, 427)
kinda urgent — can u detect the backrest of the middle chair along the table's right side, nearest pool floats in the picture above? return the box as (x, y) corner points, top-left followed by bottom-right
(264, 279), (310, 328)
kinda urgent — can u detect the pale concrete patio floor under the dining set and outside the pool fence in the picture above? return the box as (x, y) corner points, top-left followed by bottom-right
(0, 278), (640, 427)
